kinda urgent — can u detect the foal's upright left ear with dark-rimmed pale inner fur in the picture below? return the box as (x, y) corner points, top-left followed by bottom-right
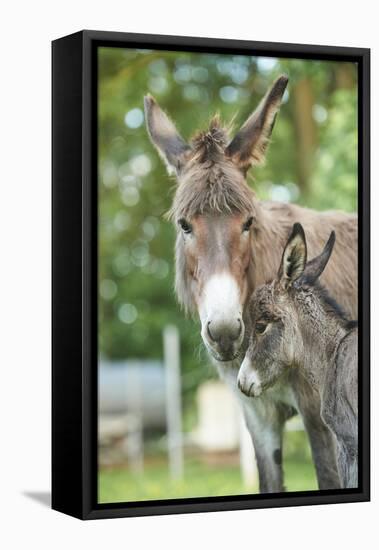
(278, 223), (307, 288)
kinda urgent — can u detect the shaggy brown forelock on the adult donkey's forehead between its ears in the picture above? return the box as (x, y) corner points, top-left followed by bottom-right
(167, 115), (254, 221)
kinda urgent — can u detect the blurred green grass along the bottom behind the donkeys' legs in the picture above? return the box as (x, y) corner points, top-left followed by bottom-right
(99, 433), (317, 503)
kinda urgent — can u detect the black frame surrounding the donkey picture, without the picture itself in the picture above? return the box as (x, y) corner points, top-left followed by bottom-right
(52, 30), (370, 519)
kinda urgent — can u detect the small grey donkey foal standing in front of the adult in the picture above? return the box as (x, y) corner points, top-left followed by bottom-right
(238, 223), (358, 488)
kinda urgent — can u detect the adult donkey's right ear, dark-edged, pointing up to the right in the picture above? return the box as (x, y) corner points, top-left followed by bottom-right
(226, 75), (288, 172)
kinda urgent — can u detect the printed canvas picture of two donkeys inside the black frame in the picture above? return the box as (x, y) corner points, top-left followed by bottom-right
(97, 46), (359, 504)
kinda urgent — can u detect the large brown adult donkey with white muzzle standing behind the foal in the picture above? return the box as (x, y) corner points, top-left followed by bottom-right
(145, 76), (357, 492)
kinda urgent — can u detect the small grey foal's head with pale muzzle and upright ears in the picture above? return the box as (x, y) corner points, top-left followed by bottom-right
(238, 223), (335, 397)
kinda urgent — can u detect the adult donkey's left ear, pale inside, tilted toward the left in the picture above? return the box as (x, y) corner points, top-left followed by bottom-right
(144, 95), (191, 173)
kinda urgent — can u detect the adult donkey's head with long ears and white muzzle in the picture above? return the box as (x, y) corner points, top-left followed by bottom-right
(145, 76), (288, 361)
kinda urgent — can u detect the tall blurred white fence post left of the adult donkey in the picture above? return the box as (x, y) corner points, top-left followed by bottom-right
(163, 325), (183, 479)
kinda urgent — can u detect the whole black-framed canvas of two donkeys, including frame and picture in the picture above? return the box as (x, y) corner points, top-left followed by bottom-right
(52, 31), (370, 519)
